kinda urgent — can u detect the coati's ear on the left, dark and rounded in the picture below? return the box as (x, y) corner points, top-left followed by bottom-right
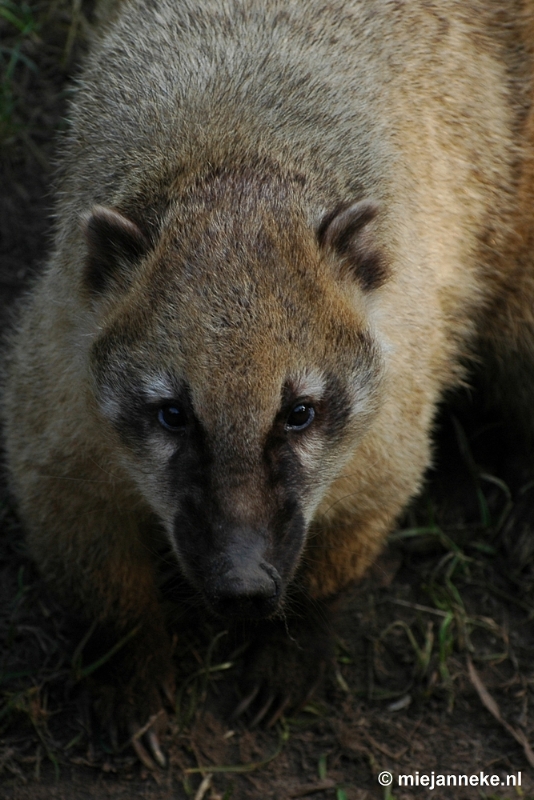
(82, 206), (148, 294)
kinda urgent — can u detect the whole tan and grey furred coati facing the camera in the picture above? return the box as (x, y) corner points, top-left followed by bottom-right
(3, 0), (534, 763)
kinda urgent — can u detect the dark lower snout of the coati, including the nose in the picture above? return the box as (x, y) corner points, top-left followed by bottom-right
(171, 476), (306, 619)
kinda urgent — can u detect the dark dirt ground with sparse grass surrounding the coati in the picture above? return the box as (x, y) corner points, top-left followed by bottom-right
(0, 0), (534, 800)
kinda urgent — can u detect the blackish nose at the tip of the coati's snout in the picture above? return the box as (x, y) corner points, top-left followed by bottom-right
(206, 562), (281, 619)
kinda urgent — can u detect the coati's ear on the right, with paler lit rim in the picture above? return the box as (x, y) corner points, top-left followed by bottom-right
(317, 200), (388, 292)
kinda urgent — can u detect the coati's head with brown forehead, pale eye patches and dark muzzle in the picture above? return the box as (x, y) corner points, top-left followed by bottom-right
(84, 166), (382, 618)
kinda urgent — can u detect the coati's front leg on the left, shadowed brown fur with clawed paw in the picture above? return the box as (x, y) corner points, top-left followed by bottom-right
(14, 468), (174, 767)
